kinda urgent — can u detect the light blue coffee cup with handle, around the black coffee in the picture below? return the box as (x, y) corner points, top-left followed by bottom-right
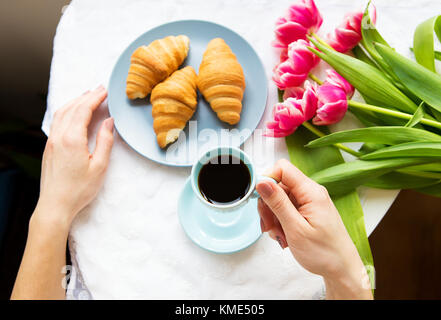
(190, 147), (276, 212)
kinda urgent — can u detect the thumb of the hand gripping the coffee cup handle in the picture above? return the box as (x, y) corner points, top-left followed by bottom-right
(256, 181), (307, 228)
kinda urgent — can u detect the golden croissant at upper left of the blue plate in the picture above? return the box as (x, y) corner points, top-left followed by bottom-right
(126, 35), (190, 99)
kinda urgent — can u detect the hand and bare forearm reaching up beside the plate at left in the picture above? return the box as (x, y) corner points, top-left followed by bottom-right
(11, 86), (113, 299)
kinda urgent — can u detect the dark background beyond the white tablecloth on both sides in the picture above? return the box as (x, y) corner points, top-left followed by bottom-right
(0, 0), (441, 299)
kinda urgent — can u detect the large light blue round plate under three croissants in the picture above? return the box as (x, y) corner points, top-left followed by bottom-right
(108, 20), (268, 166)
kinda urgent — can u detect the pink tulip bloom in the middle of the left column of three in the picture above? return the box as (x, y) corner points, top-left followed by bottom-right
(273, 40), (320, 90)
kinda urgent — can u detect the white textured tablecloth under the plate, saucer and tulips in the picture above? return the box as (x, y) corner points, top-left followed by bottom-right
(43, 0), (441, 299)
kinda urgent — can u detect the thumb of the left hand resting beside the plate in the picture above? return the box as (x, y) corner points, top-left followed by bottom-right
(92, 118), (114, 169)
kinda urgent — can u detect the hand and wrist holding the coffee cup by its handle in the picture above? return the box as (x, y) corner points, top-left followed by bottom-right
(257, 160), (372, 299)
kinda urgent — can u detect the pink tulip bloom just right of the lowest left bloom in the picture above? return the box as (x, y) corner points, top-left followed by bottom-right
(312, 83), (348, 126)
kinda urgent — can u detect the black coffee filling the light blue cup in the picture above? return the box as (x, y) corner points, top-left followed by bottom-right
(198, 155), (251, 205)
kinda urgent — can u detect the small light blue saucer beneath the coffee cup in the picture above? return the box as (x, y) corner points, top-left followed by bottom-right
(178, 178), (262, 253)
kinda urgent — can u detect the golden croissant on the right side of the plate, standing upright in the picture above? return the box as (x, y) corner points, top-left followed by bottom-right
(198, 38), (245, 124)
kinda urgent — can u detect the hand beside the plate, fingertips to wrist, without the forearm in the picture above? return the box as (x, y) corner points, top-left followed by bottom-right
(35, 86), (113, 226)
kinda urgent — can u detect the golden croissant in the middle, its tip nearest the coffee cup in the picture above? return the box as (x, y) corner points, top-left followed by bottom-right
(150, 66), (198, 148)
